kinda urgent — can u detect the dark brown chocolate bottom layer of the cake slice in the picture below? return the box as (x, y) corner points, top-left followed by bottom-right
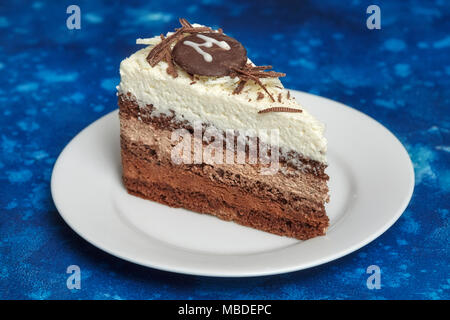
(121, 136), (328, 240)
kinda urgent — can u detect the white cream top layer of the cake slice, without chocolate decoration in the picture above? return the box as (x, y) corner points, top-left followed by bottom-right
(118, 24), (327, 163)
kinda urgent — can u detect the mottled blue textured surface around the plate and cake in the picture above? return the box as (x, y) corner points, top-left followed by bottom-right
(0, 0), (450, 299)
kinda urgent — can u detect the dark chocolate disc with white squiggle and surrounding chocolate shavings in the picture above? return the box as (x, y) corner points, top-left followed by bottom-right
(147, 18), (286, 102)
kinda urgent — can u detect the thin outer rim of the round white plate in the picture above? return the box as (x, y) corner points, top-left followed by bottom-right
(50, 89), (415, 278)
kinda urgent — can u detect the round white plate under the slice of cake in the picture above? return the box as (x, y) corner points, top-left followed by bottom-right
(51, 91), (414, 277)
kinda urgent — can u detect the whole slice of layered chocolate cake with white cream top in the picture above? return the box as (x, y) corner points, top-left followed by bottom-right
(118, 19), (329, 239)
